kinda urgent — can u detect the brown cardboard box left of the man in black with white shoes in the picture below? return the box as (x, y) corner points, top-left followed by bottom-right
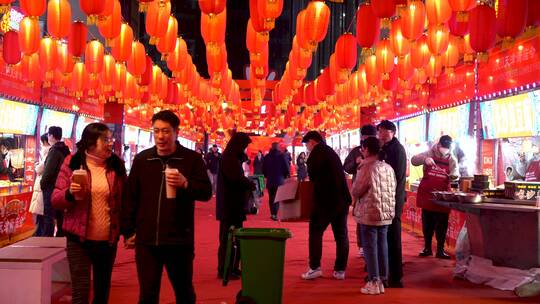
(276, 179), (313, 221)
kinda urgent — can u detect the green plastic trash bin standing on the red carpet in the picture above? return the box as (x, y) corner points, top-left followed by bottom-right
(224, 228), (291, 304)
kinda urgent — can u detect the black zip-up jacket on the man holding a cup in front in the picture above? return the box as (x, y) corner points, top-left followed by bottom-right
(121, 143), (212, 245)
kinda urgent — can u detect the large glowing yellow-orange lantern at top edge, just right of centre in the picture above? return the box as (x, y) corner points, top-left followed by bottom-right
(303, 0), (330, 50)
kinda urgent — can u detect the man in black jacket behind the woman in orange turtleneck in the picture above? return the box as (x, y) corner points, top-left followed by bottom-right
(34, 126), (69, 237)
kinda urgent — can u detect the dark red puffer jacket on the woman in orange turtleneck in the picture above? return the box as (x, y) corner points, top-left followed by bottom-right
(52, 155), (125, 243)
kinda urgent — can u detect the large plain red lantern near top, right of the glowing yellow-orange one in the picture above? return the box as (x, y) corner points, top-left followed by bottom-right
(356, 2), (381, 49)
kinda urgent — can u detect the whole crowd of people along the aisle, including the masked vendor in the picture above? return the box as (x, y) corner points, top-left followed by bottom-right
(22, 110), (459, 303)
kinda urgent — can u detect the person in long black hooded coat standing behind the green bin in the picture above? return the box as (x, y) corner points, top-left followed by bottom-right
(216, 132), (255, 279)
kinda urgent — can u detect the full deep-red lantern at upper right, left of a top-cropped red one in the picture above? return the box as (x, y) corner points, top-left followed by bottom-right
(469, 4), (497, 53)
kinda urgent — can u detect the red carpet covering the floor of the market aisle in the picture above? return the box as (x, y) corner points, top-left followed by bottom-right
(54, 196), (540, 304)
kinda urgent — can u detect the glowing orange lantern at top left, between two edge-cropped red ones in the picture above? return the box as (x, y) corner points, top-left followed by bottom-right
(47, 0), (71, 39)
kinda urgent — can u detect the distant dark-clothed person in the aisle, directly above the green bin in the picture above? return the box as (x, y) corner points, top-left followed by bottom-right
(263, 142), (289, 221)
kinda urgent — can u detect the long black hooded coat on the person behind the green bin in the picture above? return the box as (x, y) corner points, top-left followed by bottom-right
(216, 132), (255, 222)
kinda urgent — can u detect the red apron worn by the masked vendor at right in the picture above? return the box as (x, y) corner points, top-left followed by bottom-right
(416, 157), (450, 213)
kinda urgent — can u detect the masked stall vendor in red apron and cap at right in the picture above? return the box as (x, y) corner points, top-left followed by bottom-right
(411, 135), (459, 259)
